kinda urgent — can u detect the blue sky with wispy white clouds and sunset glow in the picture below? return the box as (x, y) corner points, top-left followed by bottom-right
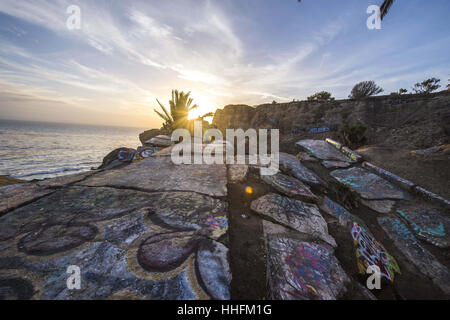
(0, 0), (450, 128)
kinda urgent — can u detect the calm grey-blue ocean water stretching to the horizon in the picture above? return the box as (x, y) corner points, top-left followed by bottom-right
(0, 120), (144, 180)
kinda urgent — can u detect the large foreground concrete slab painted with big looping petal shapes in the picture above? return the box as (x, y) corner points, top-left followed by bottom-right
(0, 186), (231, 300)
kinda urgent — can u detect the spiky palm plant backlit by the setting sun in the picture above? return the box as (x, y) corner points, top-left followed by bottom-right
(154, 90), (198, 131)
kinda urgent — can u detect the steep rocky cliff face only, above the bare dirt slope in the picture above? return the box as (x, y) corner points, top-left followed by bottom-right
(213, 92), (450, 149)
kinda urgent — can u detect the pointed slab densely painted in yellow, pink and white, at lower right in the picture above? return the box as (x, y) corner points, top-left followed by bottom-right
(352, 222), (401, 281)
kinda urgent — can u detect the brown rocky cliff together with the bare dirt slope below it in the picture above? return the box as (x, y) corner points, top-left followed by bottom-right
(213, 91), (450, 198)
